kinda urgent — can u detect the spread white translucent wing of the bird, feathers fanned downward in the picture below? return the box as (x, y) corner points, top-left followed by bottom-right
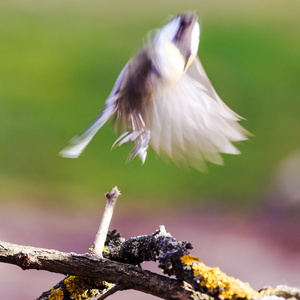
(144, 55), (247, 170)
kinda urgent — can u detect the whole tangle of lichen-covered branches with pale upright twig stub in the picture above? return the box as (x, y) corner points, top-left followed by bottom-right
(0, 188), (300, 300)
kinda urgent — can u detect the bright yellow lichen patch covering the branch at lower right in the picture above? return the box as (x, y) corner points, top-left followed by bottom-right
(181, 255), (259, 299)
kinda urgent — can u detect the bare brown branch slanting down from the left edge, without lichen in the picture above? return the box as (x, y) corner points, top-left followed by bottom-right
(0, 241), (207, 299)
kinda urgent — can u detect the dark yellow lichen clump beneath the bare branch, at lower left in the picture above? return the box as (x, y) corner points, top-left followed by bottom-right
(64, 276), (113, 300)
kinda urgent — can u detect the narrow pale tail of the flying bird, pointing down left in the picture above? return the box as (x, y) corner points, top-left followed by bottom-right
(59, 99), (116, 158)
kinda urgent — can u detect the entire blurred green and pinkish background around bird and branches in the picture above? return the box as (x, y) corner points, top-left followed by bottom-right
(0, 0), (300, 299)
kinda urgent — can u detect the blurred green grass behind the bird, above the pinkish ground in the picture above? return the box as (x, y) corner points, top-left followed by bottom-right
(0, 0), (300, 205)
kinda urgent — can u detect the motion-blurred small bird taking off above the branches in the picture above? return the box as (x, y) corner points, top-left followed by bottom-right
(60, 11), (249, 171)
